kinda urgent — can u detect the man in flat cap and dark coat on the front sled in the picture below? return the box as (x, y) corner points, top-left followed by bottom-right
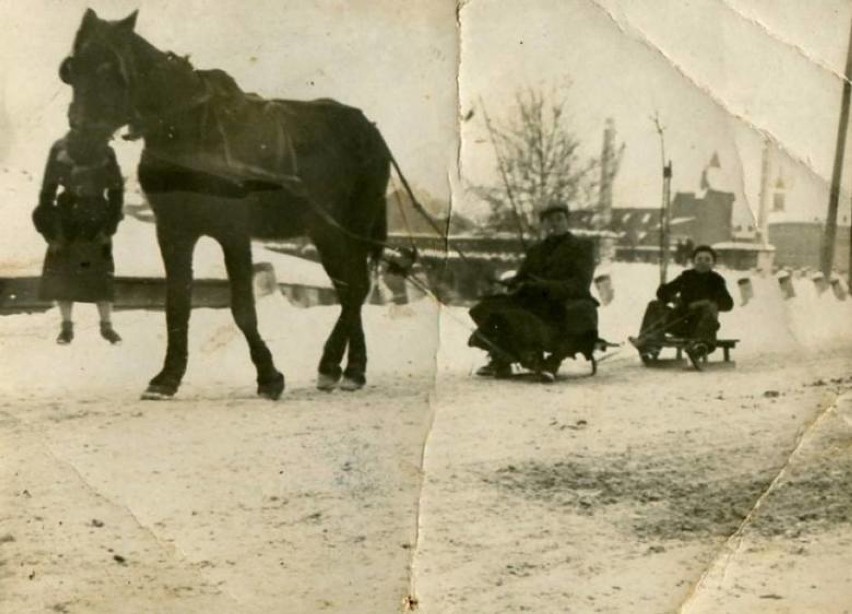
(468, 205), (598, 382)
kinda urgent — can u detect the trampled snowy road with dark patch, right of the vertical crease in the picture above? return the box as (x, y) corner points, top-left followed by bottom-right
(415, 350), (852, 614)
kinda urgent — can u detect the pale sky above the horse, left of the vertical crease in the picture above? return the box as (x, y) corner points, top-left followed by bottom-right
(0, 0), (458, 198)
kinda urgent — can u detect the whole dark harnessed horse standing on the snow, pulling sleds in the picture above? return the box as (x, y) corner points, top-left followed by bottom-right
(60, 9), (391, 399)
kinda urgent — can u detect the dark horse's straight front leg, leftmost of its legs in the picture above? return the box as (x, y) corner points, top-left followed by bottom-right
(142, 226), (198, 400)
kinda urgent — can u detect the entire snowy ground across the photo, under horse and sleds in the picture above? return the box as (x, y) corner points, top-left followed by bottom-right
(0, 276), (852, 614)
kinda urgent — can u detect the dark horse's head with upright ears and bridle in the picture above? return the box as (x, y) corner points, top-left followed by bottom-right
(59, 9), (138, 134)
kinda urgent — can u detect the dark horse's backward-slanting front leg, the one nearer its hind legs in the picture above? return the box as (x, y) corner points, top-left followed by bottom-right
(220, 236), (284, 399)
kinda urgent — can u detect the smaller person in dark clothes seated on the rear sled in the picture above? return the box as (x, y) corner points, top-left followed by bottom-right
(630, 245), (734, 363)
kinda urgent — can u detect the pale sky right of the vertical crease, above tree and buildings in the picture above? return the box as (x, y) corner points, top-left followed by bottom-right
(460, 0), (852, 227)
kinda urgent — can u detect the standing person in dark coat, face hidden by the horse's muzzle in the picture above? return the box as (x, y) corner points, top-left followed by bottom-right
(32, 129), (124, 345)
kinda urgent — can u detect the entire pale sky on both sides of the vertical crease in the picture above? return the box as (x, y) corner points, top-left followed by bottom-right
(0, 0), (852, 248)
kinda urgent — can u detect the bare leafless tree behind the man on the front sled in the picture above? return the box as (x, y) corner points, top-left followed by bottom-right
(476, 88), (623, 233)
